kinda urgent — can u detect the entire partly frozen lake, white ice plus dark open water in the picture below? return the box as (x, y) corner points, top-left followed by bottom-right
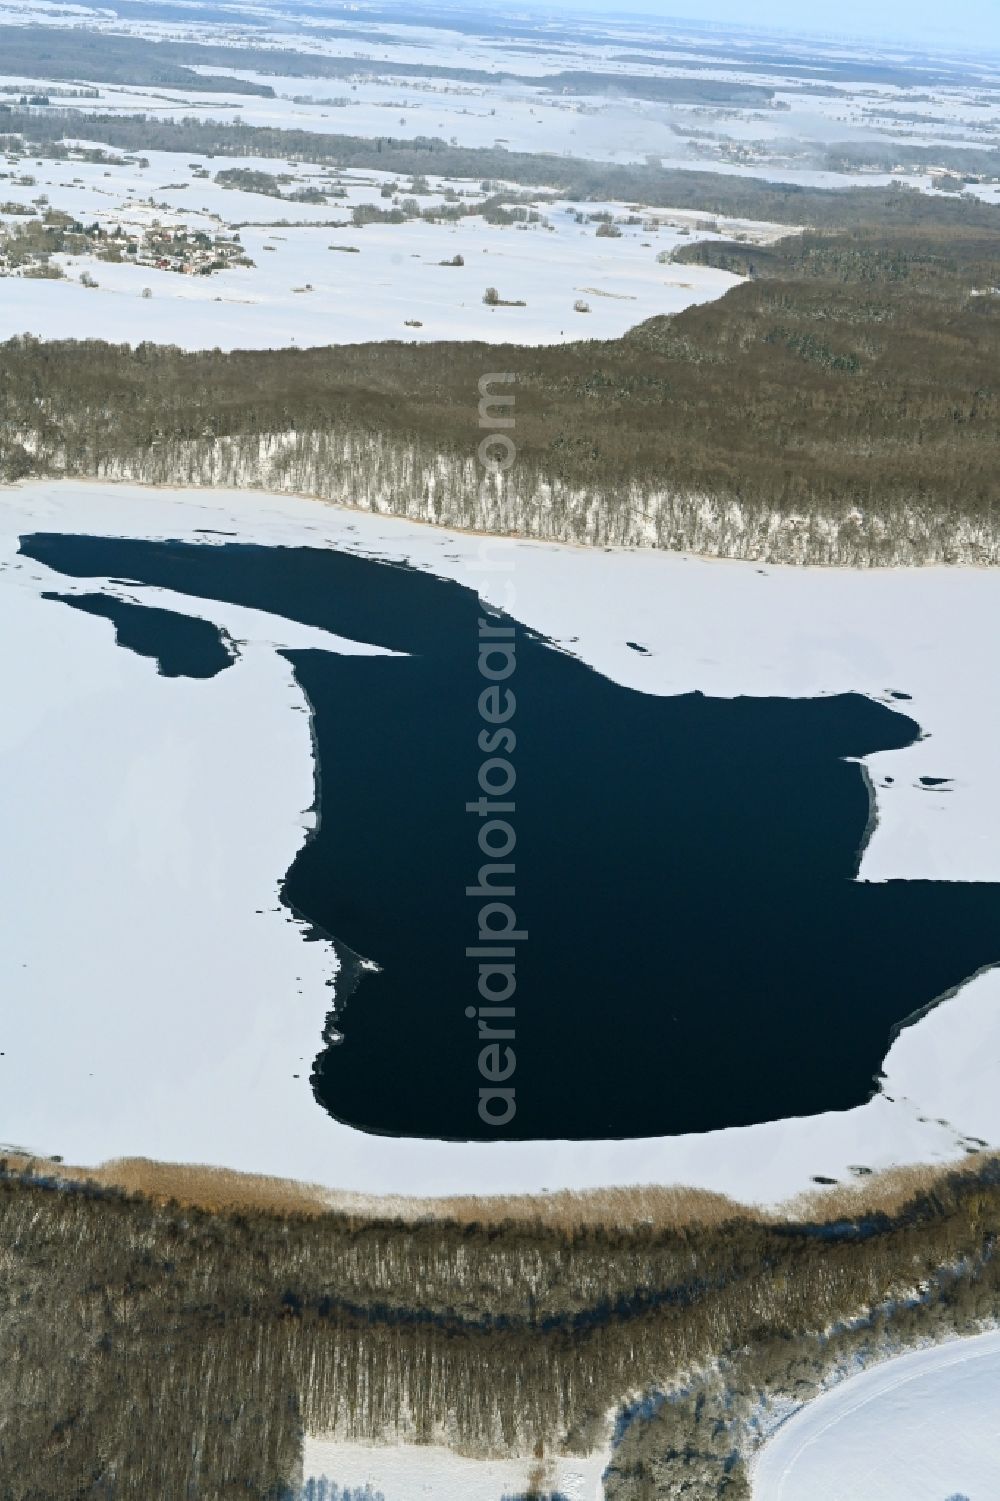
(0, 483), (1000, 1202)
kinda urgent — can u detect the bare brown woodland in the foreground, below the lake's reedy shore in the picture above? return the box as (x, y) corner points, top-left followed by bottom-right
(0, 1159), (1000, 1501)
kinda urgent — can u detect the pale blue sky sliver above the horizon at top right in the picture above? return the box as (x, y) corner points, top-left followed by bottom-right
(537, 0), (1000, 54)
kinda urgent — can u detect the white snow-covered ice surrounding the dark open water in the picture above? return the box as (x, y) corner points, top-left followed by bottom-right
(0, 483), (1000, 1202)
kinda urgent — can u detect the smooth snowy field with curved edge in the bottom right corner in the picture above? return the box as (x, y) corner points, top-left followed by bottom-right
(752, 1330), (1000, 1501)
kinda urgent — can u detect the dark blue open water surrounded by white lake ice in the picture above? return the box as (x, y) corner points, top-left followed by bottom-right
(23, 534), (1000, 1139)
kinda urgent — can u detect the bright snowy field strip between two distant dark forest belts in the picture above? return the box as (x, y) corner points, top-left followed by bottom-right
(9, 64), (1000, 194)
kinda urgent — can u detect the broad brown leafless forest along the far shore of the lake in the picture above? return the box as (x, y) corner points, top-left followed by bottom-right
(0, 214), (1000, 564)
